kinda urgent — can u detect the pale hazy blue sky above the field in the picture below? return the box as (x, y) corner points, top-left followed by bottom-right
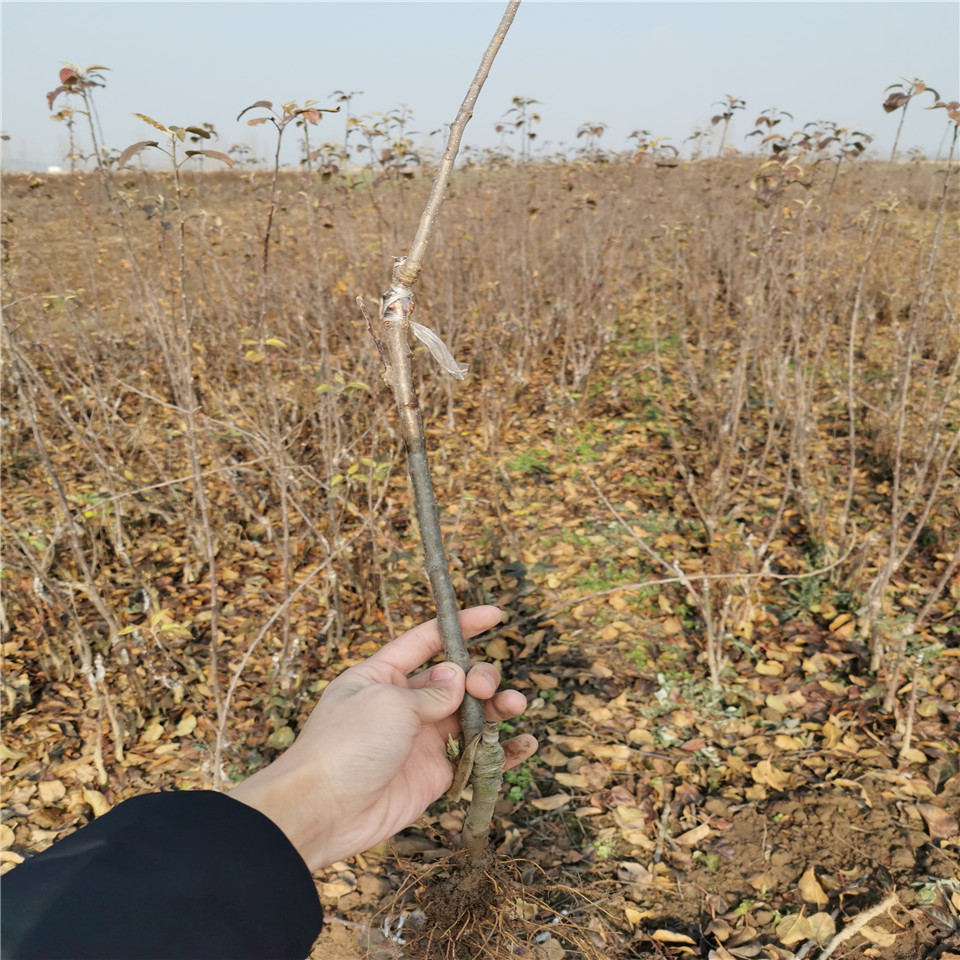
(0, 0), (960, 170)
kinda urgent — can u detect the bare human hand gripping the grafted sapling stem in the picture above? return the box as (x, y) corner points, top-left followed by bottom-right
(230, 606), (537, 870)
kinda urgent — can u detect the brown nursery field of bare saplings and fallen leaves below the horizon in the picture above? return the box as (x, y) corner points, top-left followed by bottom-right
(0, 146), (960, 960)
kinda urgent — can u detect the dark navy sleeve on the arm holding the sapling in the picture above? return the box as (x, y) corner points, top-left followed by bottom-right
(0, 791), (323, 960)
